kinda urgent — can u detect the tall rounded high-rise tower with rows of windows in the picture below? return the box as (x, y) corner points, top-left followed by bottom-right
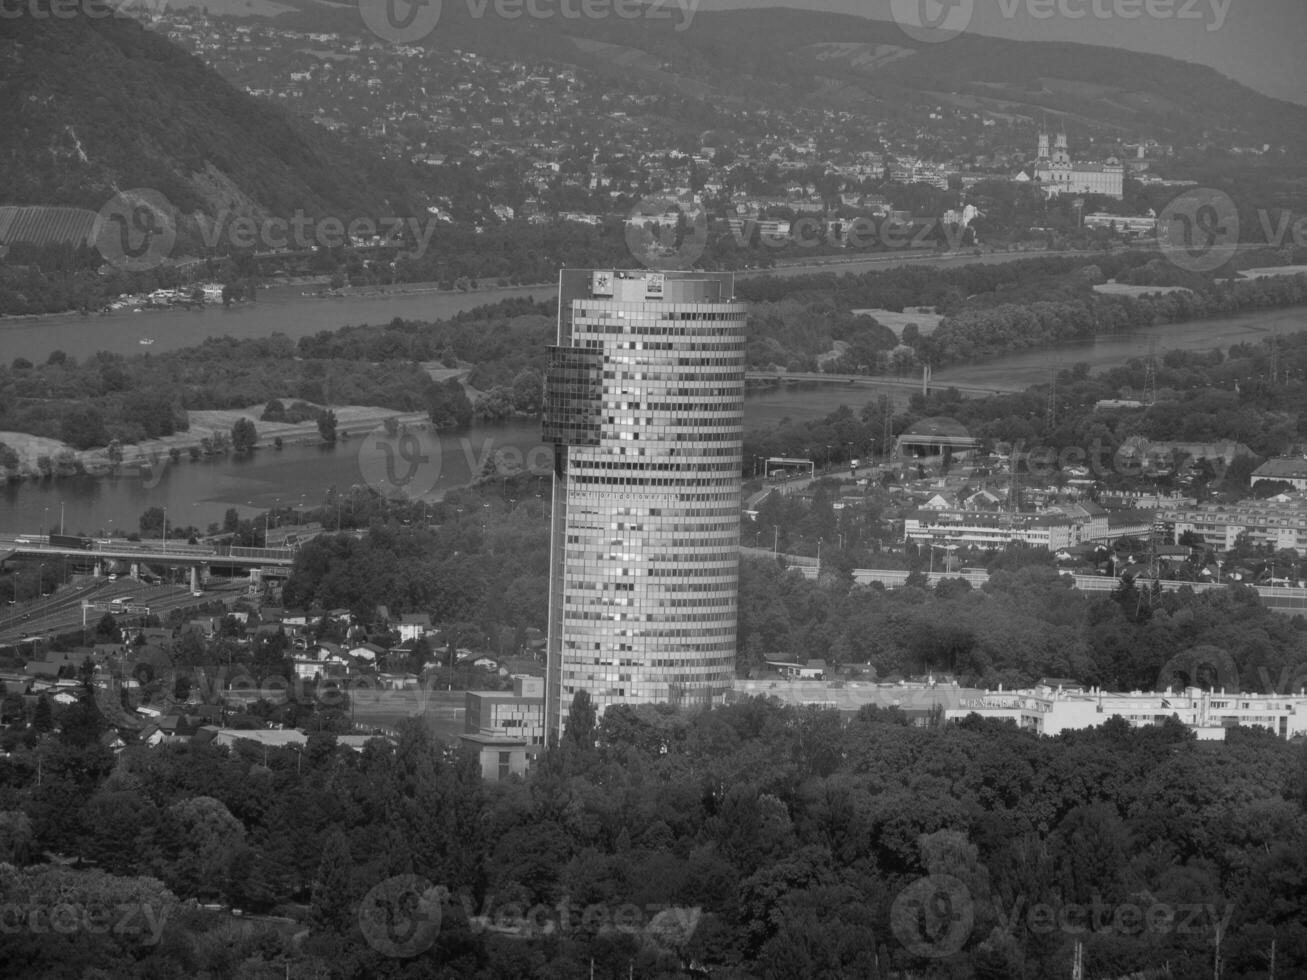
(544, 269), (746, 741)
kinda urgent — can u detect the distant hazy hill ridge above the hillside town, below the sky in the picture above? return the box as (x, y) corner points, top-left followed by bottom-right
(275, 0), (1307, 149)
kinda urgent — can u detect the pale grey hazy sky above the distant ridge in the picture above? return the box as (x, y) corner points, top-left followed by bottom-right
(711, 0), (1307, 105)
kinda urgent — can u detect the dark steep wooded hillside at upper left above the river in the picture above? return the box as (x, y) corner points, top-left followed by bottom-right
(0, 0), (421, 244)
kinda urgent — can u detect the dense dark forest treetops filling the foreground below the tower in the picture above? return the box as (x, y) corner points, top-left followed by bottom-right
(0, 695), (1307, 980)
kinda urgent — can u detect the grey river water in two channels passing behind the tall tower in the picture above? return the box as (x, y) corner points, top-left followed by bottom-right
(0, 261), (1307, 533)
